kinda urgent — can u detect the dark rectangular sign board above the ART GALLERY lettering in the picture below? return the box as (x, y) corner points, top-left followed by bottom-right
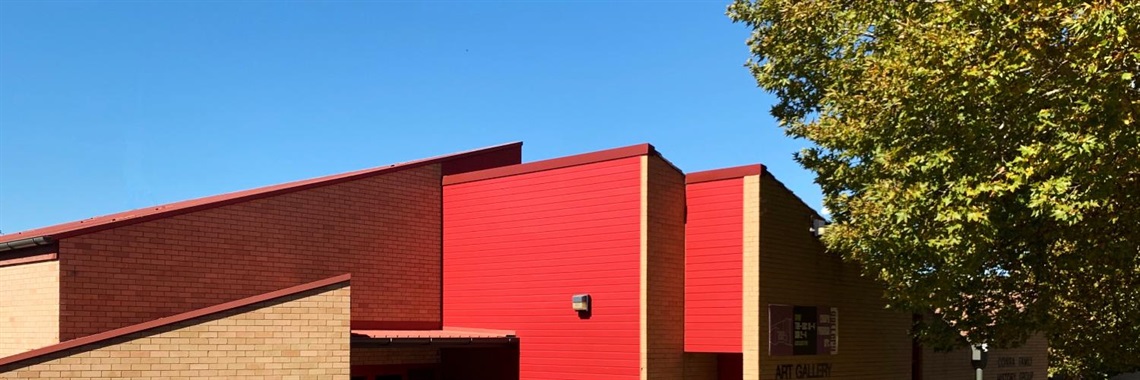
(768, 305), (839, 356)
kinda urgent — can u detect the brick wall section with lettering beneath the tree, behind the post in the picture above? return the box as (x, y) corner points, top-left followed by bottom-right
(922, 335), (1049, 380)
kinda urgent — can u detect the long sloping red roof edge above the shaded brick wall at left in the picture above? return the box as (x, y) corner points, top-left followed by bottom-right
(0, 142), (522, 243)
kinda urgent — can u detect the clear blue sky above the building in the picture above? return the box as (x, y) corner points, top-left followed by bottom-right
(0, 0), (821, 233)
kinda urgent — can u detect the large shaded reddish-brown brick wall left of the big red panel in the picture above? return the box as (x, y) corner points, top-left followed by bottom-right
(59, 164), (442, 340)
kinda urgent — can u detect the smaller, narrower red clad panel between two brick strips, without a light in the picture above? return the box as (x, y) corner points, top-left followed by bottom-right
(685, 178), (744, 353)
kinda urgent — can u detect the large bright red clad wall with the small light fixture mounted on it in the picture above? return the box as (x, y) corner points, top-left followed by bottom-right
(443, 156), (642, 379)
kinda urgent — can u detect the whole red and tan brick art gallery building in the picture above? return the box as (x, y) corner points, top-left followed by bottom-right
(0, 143), (1048, 380)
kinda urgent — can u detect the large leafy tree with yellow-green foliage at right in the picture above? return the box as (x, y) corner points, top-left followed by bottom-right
(727, 0), (1140, 378)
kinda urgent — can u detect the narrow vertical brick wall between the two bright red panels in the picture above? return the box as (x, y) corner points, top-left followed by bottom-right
(643, 156), (685, 379)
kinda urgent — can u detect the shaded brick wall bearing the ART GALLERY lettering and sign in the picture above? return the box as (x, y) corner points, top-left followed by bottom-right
(746, 175), (912, 380)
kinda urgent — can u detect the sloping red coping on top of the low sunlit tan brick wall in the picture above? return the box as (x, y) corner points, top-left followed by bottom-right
(0, 274), (351, 366)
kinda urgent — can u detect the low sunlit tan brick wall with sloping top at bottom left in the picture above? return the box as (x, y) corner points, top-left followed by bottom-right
(0, 280), (350, 379)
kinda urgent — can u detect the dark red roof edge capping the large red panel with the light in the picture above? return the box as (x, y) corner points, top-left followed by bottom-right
(443, 144), (671, 186)
